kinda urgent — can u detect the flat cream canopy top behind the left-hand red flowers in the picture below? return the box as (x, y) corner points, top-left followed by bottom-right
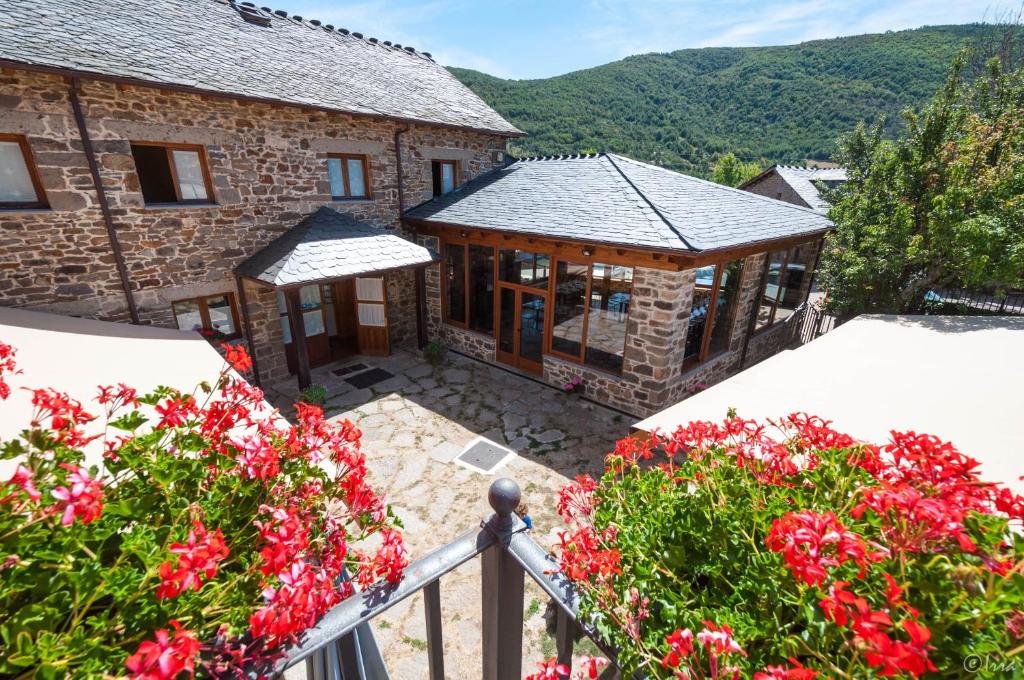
(0, 307), (258, 478)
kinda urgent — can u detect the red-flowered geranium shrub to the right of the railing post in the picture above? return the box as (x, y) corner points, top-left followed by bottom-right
(558, 414), (1024, 680)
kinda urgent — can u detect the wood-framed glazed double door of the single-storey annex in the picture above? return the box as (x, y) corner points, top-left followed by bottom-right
(497, 284), (548, 374)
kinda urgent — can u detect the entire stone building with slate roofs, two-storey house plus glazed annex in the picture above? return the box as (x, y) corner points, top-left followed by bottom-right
(0, 0), (830, 414)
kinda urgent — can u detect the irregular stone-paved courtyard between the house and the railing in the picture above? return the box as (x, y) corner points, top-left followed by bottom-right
(267, 351), (632, 680)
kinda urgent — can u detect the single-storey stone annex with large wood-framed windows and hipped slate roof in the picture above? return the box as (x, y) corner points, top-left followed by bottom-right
(406, 154), (831, 414)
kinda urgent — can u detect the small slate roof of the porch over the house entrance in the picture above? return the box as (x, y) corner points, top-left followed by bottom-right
(234, 208), (437, 287)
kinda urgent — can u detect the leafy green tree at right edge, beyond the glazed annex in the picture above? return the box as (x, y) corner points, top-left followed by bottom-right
(819, 52), (1024, 315)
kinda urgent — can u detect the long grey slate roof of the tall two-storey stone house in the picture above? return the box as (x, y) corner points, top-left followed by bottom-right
(0, 0), (522, 135)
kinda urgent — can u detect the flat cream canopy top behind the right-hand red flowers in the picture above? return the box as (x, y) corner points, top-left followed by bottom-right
(634, 315), (1024, 493)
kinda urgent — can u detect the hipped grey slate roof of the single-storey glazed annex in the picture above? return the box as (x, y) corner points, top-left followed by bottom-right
(406, 154), (831, 252)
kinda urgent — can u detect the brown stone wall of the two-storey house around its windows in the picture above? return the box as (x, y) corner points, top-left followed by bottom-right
(0, 71), (505, 385)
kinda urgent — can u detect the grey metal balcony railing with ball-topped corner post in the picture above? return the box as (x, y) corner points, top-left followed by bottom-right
(274, 479), (618, 680)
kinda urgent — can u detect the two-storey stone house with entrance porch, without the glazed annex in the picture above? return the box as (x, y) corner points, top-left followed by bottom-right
(0, 0), (521, 381)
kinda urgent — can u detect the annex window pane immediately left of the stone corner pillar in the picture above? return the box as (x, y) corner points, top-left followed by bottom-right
(585, 262), (633, 373)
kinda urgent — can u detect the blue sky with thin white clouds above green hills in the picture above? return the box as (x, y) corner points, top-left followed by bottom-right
(284, 0), (1020, 78)
